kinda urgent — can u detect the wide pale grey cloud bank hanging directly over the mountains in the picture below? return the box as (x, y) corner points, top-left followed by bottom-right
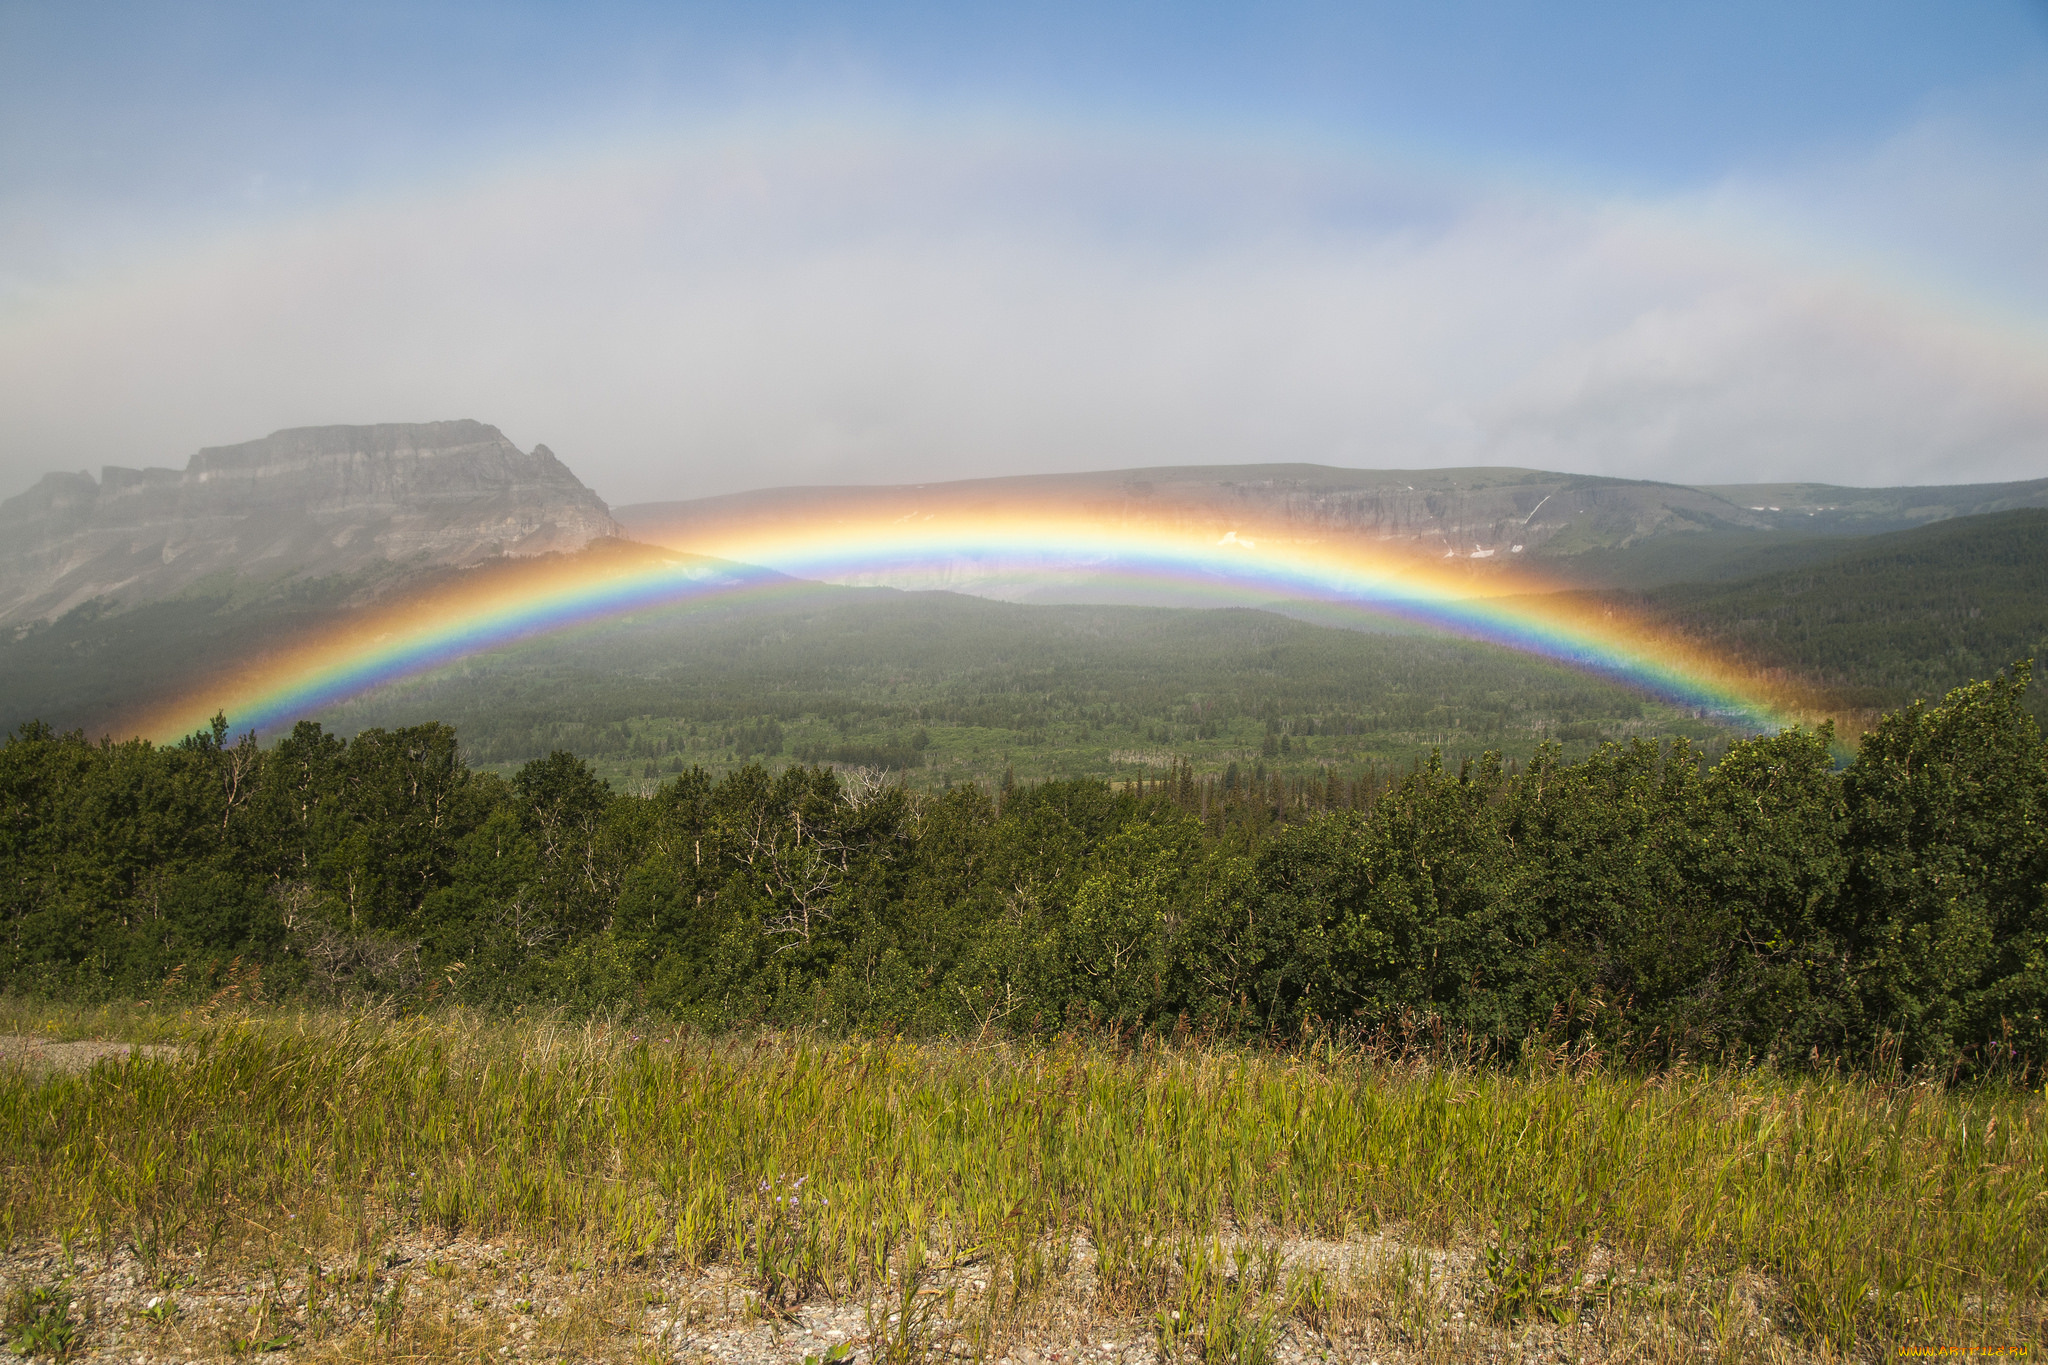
(0, 113), (2048, 503)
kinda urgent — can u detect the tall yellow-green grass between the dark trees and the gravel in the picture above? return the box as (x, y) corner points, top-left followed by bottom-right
(0, 998), (2048, 1353)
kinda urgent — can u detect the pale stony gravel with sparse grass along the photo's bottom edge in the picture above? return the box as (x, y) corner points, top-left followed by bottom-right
(0, 1238), (1812, 1365)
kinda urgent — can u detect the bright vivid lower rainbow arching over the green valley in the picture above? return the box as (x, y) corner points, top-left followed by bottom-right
(133, 510), (1794, 741)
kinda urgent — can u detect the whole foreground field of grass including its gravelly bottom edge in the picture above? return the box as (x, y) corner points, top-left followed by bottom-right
(0, 1001), (2048, 1365)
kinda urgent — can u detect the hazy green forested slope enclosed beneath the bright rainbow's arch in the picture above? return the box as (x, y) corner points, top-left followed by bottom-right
(317, 587), (1695, 790)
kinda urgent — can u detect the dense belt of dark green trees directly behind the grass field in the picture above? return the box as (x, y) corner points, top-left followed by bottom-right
(0, 665), (2048, 1072)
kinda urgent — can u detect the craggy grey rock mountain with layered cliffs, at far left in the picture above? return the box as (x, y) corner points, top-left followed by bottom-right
(0, 422), (618, 622)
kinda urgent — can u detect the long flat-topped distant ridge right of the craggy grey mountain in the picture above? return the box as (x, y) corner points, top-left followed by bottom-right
(616, 465), (2048, 600)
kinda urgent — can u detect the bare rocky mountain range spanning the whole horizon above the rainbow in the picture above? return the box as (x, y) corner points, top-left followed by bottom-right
(0, 420), (2048, 626)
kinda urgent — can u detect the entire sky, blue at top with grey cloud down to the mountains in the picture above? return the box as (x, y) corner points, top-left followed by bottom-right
(0, 0), (2048, 505)
